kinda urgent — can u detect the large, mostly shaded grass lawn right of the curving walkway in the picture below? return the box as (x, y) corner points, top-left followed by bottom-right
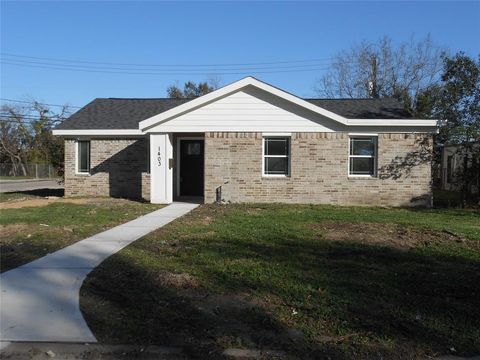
(81, 205), (480, 359)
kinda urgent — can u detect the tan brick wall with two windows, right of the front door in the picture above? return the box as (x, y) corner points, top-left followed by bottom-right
(205, 132), (432, 206)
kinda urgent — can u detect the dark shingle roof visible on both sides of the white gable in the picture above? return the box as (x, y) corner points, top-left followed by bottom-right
(57, 98), (412, 130)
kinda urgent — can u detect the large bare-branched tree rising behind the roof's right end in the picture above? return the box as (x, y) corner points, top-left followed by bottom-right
(315, 36), (446, 109)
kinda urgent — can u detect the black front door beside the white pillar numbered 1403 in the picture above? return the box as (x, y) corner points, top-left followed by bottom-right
(179, 139), (204, 196)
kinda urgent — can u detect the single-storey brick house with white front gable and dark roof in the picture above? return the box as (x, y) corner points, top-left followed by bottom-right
(54, 77), (437, 206)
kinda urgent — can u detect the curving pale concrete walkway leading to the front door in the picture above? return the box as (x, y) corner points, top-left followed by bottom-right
(0, 203), (198, 342)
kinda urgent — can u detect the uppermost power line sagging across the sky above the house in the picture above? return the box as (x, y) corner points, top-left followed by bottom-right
(0, 53), (334, 67)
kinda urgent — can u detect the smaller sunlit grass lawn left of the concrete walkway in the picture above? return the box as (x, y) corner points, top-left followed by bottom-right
(0, 193), (159, 271)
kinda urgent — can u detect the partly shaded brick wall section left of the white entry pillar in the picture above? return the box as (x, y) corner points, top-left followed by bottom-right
(65, 138), (150, 199)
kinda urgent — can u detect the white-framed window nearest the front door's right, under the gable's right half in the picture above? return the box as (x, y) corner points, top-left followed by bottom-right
(263, 137), (290, 176)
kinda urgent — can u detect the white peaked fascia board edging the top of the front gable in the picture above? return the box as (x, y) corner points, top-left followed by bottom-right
(139, 76), (347, 131)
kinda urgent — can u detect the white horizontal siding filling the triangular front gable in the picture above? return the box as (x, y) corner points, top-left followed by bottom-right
(148, 87), (339, 133)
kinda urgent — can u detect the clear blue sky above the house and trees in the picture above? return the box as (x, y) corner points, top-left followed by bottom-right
(0, 1), (480, 109)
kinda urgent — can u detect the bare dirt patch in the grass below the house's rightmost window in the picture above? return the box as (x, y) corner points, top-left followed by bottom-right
(312, 222), (466, 248)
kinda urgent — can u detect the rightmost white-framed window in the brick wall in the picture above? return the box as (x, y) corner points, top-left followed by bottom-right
(348, 136), (377, 176)
